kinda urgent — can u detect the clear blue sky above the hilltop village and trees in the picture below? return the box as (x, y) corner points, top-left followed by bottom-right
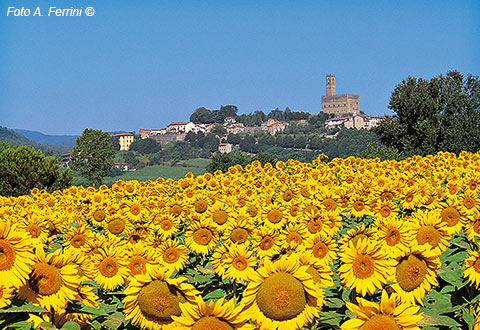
(0, 0), (480, 134)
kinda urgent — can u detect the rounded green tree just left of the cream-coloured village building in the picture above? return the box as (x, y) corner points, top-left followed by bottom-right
(71, 128), (115, 185)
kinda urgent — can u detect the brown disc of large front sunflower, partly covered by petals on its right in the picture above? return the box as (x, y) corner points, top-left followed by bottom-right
(138, 280), (186, 322)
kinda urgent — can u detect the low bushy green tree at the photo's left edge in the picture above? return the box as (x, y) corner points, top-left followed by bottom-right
(0, 143), (73, 196)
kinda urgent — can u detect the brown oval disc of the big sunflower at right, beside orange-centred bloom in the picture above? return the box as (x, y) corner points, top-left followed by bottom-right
(395, 254), (427, 292)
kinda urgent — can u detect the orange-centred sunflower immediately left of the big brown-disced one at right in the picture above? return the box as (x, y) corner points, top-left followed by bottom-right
(338, 238), (392, 296)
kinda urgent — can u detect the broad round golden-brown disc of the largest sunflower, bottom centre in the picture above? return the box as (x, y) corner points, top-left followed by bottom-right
(257, 272), (307, 321)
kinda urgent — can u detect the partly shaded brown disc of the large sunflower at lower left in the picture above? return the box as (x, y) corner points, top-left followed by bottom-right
(28, 262), (63, 296)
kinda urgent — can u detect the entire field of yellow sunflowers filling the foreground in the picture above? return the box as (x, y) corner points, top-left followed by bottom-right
(0, 152), (480, 330)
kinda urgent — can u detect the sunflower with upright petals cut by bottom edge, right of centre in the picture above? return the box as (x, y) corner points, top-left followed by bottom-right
(341, 291), (423, 330)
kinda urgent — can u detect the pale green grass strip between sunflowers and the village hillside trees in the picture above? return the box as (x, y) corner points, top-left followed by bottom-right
(73, 158), (210, 186)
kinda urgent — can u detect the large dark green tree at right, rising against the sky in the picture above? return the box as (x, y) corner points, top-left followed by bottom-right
(375, 71), (480, 156)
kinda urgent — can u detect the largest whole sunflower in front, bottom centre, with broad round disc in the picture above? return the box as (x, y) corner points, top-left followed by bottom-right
(241, 254), (324, 330)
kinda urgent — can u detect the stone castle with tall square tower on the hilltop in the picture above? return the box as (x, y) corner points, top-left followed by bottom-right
(322, 74), (360, 116)
